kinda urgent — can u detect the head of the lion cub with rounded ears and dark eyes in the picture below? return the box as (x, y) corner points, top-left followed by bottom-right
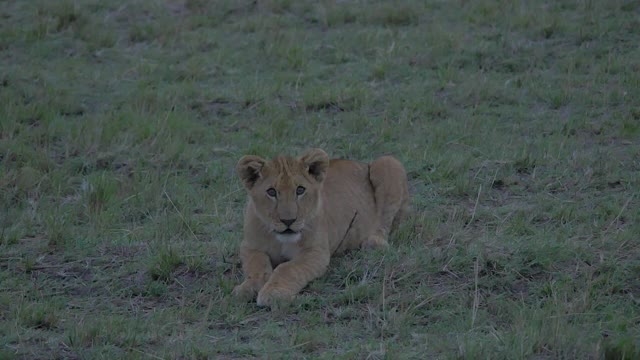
(236, 149), (329, 242)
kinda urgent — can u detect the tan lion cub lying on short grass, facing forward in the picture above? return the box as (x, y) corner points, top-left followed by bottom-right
(233, 149), (409, 306)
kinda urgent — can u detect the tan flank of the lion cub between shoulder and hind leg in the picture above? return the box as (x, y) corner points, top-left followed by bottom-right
(323, 159), (378, 252)
